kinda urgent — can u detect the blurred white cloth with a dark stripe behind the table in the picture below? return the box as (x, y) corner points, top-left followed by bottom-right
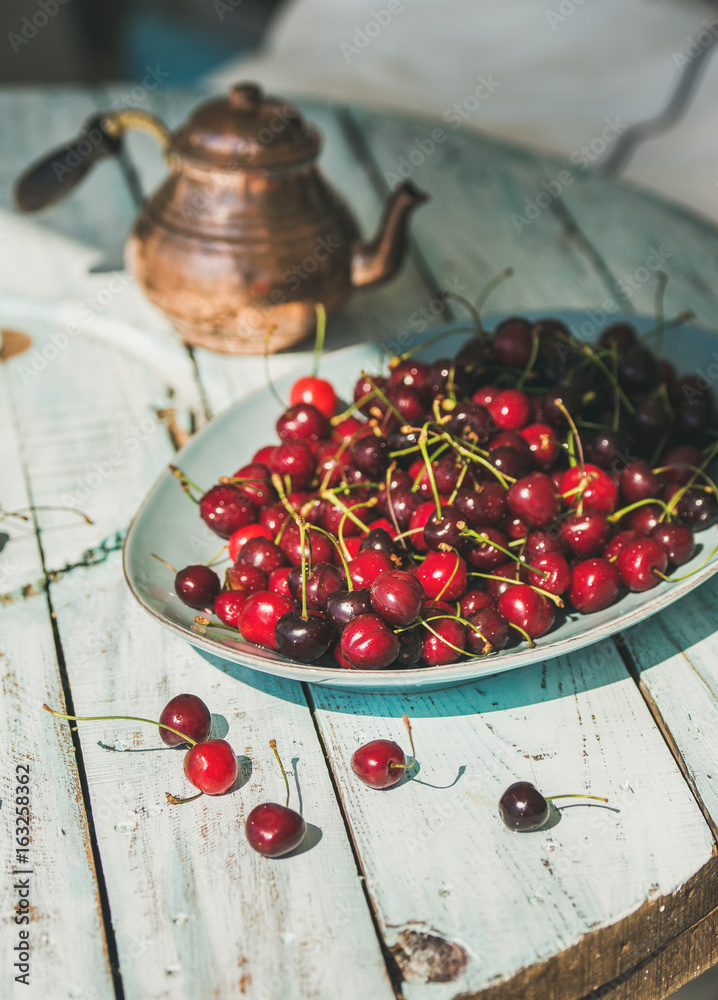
(211, 0), (718, 221)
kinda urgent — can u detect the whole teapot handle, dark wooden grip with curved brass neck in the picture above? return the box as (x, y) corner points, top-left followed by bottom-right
(14, 108), (172, 212)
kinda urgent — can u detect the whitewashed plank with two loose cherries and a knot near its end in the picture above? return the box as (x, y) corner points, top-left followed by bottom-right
(312, 643), (716, 1000)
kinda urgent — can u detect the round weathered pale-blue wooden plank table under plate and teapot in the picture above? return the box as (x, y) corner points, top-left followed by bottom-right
(0, 87), (718, 1000)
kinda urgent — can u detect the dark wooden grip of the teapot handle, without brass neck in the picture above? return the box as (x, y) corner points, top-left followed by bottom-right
(15, 115), (122, 212)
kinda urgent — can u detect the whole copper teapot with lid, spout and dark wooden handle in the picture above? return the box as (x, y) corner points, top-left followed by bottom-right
(15, 83), (427, 354)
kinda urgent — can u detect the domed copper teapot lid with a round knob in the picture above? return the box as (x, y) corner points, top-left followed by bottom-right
(173, 83), (321, 169)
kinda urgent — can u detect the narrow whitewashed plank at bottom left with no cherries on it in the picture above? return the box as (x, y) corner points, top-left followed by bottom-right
(0, 372), (115, 1000)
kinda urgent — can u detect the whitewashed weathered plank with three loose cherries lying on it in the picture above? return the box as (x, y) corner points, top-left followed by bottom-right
(50, 553), (394, 1000)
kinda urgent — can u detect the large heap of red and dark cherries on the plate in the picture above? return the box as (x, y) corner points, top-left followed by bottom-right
(173, 317), (718, 670)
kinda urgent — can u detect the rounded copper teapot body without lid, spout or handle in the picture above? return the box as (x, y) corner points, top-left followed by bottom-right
(127, 159), (359, 354)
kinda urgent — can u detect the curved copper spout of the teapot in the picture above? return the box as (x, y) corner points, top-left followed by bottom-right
(351, 181), (429, 288)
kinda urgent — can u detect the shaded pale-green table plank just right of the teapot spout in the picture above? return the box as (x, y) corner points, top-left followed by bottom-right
(352, 110), (620, 311)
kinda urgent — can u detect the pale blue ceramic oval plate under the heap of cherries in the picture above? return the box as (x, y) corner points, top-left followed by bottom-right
(124, 312), (718, 691)
